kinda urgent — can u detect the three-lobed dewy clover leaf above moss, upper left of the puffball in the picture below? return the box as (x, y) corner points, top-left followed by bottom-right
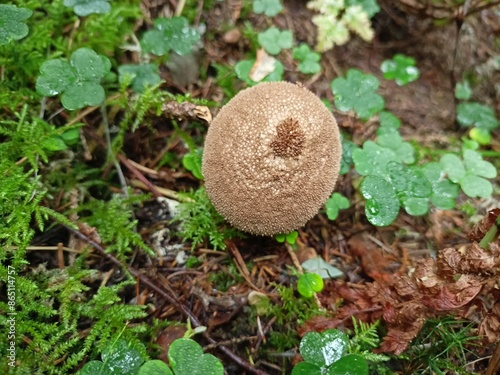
(36, 48), (111, 110)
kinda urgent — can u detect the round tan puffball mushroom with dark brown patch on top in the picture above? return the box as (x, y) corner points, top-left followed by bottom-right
(202, 82), (342, 236)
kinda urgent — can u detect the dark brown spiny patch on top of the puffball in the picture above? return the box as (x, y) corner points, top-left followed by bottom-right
(270, 118), (306, 158)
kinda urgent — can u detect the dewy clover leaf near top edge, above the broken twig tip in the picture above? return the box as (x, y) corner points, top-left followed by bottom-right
(141, 17), (200, 56)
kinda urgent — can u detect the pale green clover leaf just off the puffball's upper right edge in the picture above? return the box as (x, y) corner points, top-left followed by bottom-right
(331, 69), (385, 120)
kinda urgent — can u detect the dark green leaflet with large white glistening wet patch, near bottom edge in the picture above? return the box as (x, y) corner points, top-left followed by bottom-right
(300, 329), (349, 369)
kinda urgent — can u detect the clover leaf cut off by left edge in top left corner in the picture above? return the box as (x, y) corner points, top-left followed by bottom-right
(0, 4), (33, 46)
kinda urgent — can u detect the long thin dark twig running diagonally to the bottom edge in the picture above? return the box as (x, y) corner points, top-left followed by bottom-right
(67, 227), (268, 375)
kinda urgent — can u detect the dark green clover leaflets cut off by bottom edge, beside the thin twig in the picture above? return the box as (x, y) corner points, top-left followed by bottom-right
(168, 338), (224, 375)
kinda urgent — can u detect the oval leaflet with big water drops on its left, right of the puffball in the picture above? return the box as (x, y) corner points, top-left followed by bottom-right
(360, 176), (400, 226)
